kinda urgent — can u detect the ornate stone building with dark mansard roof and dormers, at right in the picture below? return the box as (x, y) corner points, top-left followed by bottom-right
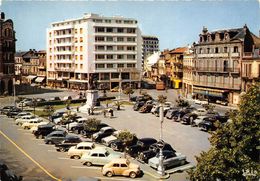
(192, 25), (254, 104)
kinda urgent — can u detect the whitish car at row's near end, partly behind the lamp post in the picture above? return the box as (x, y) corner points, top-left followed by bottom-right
(148, 150), (186, 169)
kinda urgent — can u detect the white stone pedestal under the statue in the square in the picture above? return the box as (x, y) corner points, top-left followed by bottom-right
(79, 90), (98, 114)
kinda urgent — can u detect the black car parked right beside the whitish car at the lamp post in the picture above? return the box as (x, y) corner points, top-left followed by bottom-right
(137, 143), (176, 163)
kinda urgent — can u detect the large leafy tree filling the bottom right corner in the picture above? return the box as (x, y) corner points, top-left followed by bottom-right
(189, 83), (260, 181)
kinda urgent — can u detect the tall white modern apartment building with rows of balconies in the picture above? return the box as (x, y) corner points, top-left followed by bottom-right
(47, 14), (142, 90)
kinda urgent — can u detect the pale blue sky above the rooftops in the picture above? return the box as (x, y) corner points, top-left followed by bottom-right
(0, 0), (260, 51)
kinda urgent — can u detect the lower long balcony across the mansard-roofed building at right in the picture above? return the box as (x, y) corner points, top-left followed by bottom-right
(193, 67), (240, 73)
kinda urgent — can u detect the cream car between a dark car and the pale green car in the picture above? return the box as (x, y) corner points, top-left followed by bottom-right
(68, 142), (96, 159)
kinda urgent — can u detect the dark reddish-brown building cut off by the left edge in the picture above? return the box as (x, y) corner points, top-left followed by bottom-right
(0, 12), (16, 95)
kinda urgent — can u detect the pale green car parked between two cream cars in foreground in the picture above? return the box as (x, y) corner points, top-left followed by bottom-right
(81, 147), (122, 166)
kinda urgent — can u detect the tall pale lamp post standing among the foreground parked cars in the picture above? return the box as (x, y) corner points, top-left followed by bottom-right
(157, 103), (165, 176)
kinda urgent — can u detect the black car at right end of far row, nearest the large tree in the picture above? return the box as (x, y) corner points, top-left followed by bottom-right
(199, 115), (228, 131)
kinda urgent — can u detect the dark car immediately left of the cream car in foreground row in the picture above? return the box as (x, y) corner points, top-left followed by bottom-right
(55, 135), (82, 152)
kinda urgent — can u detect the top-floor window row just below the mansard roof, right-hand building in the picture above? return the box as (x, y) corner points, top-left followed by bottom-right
(195, 46), (238, 54)
